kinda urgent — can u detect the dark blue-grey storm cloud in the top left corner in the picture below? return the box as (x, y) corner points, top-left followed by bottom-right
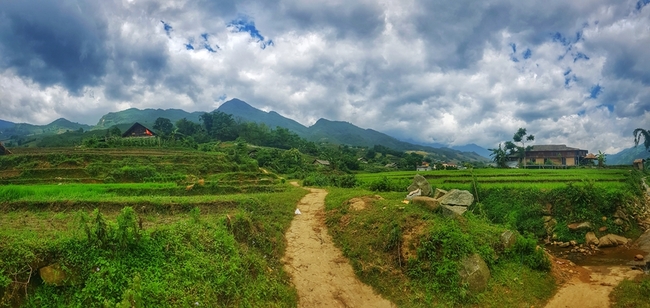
(0, 0), (108, 93)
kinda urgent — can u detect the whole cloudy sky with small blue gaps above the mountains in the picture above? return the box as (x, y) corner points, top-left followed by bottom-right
(0, 0), (650, 154)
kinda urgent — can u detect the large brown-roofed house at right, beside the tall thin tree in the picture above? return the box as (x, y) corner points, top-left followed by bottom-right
(510, 144), (588, 166)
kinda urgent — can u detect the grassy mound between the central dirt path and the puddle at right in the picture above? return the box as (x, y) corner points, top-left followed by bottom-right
(326, 188), (555, 307)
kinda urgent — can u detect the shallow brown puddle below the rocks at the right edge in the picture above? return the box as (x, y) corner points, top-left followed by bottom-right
(545, 245), (647, 266)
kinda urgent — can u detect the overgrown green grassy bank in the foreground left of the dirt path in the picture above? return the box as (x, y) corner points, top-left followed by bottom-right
(0, 185), (306, 307)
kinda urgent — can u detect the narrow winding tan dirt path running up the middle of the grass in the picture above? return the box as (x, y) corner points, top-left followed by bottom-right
(283, 183), (394, 307)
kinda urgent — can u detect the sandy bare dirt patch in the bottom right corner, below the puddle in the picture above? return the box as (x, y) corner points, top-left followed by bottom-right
(546, 266), (642, 308)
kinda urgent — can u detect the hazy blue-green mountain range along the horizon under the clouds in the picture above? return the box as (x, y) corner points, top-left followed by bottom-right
(0, 98), (650, 165)
